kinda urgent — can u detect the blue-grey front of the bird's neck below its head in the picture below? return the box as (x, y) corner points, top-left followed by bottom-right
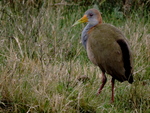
(81, 24), (95, 49)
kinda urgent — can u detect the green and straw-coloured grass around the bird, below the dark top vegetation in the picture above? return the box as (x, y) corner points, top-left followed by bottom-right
(0, 2), (150, 113)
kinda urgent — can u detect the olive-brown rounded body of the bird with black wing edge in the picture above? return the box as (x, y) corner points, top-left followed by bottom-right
(87, 24), (133, 83)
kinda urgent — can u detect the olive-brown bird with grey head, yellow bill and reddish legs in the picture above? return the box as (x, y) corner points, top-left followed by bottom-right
(72, 8), (134, 103)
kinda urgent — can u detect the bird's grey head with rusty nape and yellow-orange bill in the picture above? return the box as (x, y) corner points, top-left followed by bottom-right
(72, 9), (102, 26)
